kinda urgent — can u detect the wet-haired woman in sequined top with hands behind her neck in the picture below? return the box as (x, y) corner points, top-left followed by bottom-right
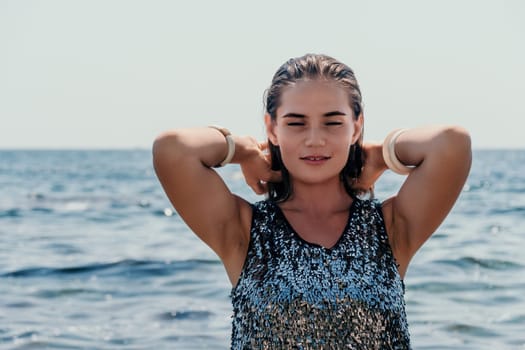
(153, 54), (471, 349)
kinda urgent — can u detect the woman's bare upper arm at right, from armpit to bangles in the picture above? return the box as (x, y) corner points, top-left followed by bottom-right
(376, 126), (472, 276)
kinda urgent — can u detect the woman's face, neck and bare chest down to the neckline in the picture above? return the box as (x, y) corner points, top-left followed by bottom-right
(265, 80), (363, 247)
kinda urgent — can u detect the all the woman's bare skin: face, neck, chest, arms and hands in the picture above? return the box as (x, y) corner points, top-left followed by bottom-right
(153, 80), (472, 286)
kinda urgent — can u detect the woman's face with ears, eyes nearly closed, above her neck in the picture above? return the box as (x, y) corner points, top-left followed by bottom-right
(266, 80), (363, 183)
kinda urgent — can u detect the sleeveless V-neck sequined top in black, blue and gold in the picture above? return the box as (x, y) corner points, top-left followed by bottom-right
(231, 199), (410, 349)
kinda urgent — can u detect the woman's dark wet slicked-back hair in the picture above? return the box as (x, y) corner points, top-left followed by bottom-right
(265, 54), (365, 202)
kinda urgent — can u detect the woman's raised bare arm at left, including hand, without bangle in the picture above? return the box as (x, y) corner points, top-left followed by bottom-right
(153, 128), (276, 284)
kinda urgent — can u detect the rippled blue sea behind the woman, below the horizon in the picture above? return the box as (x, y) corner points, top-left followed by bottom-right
(0, 150), (525, 350)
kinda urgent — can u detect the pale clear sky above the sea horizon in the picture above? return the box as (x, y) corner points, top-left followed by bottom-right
(0, 0), (525, 149)
